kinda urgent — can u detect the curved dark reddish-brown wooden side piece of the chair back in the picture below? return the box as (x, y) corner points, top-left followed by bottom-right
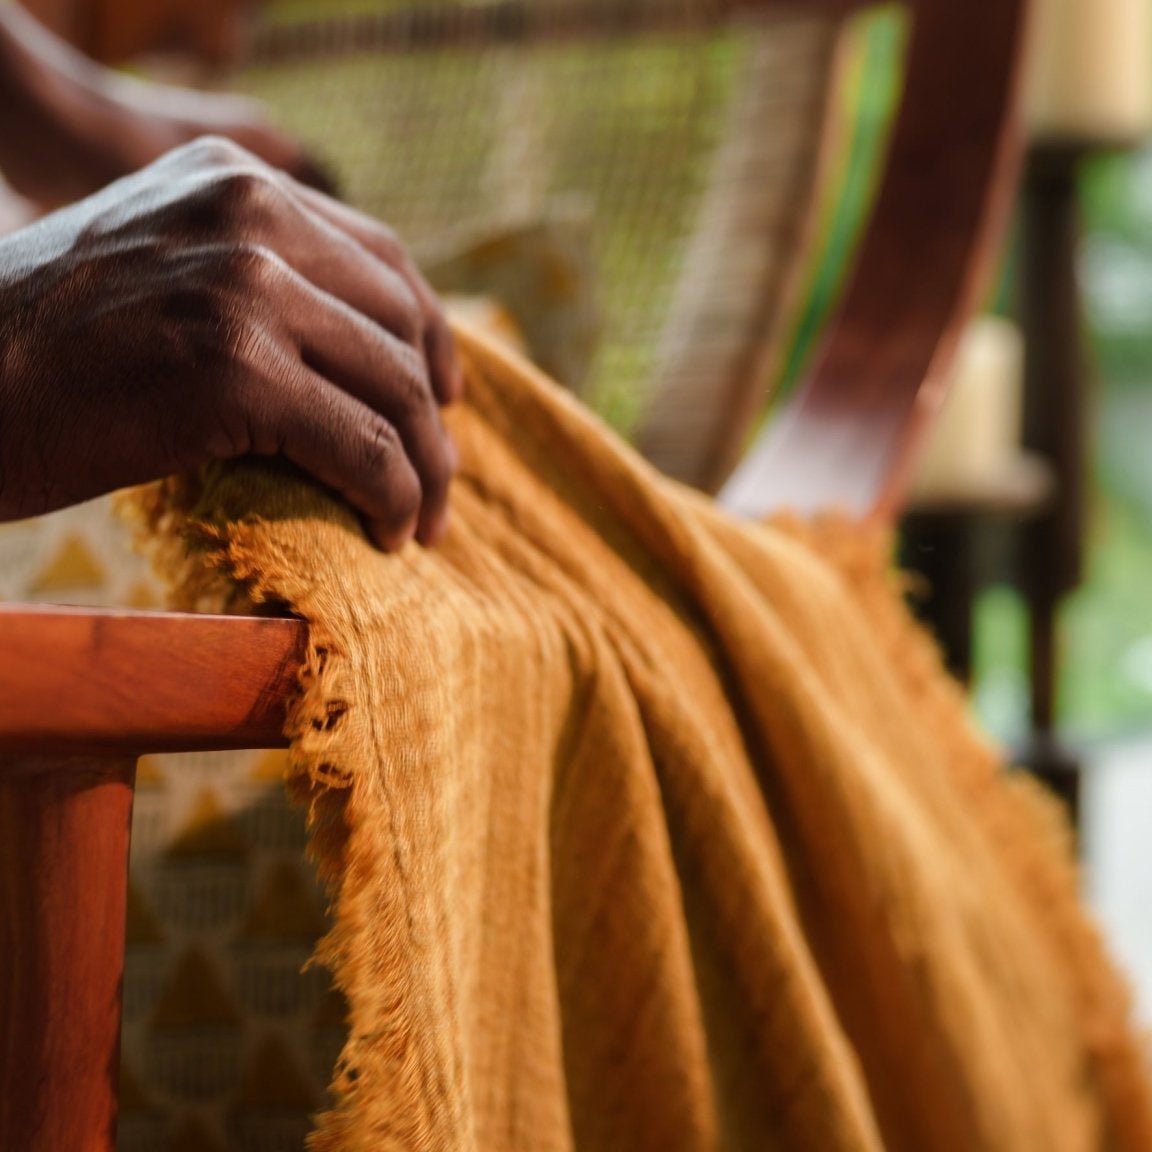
(721, 0), (1028, 517)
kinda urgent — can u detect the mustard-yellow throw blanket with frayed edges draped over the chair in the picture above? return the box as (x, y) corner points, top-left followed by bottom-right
(139, 322), (1152, 1152)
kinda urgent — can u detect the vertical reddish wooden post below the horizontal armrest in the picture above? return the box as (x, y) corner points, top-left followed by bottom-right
(0, 757), (136, 1152)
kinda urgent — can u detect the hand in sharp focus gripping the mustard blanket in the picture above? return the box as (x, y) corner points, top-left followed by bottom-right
(0, 139), (461, 548)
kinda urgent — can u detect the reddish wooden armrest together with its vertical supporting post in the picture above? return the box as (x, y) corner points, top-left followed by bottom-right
(0, 605), (308, 1152)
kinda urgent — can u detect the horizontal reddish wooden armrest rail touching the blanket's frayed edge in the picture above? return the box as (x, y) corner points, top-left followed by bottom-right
(0, 605), (306, 755)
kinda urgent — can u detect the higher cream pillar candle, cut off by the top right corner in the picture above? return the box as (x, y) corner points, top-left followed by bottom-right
(1028, 0), (1152, 144)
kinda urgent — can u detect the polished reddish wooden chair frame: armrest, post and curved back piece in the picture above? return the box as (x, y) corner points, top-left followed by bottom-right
(0, 0), (1026, 1152)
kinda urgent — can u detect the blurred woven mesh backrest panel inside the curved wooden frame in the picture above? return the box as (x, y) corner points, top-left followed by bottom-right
(226, 0), (846, 488)
